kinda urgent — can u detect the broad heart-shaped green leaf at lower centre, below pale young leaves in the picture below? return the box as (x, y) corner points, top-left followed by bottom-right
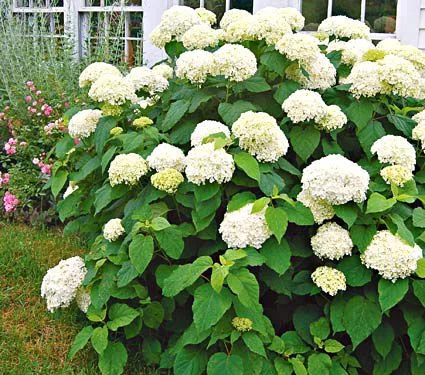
(192, 284), (232, 332)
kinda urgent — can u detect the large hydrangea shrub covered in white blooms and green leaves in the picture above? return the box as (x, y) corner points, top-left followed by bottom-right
(43, 7), (425, 375)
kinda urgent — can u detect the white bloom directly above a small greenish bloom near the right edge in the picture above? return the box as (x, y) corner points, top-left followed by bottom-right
(370, 135), (416, 171)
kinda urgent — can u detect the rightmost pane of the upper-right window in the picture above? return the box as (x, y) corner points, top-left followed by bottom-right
(366, 0), (397, 33)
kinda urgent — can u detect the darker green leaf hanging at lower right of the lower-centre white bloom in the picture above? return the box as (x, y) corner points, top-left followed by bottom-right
(260, 239), (292, 275)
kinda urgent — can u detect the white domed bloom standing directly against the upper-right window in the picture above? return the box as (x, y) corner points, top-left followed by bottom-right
(317, 16), (370, 40)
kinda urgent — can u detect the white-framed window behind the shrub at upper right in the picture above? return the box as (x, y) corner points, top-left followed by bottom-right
(301, 0), (397, 39)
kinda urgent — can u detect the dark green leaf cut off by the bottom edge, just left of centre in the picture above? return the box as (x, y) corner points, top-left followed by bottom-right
(173, 347), (208, 375)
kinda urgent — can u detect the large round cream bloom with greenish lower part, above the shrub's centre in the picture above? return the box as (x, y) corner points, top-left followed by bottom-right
(232, 111), (289, 162)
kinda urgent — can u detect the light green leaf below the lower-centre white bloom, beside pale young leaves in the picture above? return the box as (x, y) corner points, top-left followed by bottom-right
(227, 268), (260, 308)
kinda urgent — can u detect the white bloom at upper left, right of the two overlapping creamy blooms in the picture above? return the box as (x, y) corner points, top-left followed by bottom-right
(125, 66), (168, 95)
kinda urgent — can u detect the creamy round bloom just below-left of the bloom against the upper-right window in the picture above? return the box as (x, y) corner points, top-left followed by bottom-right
(276, 34), (320, 64)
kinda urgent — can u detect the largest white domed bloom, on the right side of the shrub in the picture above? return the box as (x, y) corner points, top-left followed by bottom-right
(301, 154), (369, 205)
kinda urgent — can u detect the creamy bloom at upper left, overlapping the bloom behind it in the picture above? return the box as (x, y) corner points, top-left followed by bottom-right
(88, 74), (137, 105)
